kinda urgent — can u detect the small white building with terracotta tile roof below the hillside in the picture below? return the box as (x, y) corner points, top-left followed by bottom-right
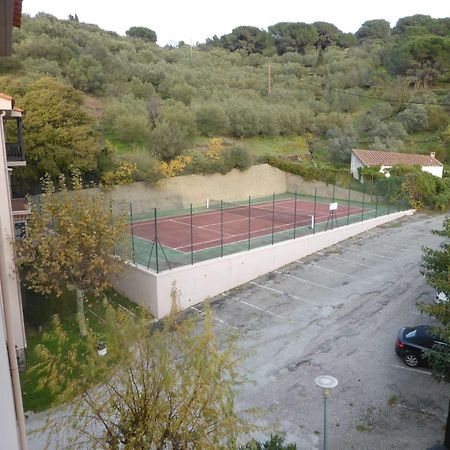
(350, 149), (444, 180)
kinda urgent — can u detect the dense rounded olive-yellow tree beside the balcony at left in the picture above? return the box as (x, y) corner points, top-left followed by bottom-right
(15, 77), (101, 184)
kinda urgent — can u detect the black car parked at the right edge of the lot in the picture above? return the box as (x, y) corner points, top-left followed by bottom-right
(395, 325), (448, 367)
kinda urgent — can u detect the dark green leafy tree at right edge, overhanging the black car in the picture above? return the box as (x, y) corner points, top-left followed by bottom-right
(418, 216), (450, 448)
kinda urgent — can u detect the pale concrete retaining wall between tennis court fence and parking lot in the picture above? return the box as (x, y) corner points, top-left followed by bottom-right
(116, 211), (413, 318)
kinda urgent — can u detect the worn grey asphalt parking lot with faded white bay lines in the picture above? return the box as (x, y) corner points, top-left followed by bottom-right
(192, 214), (449, 450)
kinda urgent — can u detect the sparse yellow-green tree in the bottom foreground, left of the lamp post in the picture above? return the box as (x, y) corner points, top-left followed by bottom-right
(35, 302), (253, 450)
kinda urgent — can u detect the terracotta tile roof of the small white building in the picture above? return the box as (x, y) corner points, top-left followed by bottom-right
(352, 148), (443, 167)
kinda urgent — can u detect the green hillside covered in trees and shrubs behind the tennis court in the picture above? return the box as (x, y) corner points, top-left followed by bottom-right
(0, 14), (450, 192)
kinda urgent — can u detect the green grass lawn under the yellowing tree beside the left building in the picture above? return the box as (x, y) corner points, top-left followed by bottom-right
(20, 289), (139, 412)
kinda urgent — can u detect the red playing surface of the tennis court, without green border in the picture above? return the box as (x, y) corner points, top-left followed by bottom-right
(133, 199), (362, 253)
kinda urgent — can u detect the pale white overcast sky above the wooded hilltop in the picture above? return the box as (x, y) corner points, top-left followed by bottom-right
(22, 0), (450, 45)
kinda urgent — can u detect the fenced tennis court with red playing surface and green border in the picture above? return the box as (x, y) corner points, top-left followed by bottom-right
(116, 188), (406, 273)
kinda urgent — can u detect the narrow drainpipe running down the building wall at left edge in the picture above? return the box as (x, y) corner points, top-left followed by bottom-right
(0, 111), (28, 450)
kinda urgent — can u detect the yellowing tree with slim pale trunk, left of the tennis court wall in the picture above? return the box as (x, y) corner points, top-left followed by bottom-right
(15, 171), (125, 336)
